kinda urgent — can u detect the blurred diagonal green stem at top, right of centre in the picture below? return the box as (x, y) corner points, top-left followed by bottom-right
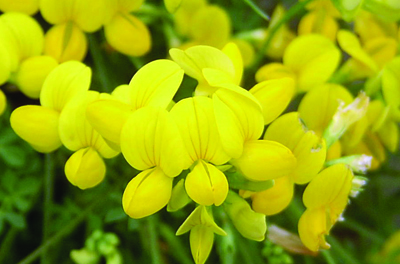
(254, 0), (313, 67)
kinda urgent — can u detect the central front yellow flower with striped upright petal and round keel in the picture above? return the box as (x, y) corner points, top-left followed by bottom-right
(171, 96), (230, 206)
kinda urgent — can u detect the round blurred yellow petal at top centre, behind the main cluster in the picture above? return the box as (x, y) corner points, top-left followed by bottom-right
(189, 5), (231, 48)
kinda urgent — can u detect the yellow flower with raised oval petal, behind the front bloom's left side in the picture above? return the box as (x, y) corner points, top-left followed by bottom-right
(86, 60), (183, 150)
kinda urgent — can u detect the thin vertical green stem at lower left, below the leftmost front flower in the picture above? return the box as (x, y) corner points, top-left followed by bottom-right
(41, 153), (54, 264)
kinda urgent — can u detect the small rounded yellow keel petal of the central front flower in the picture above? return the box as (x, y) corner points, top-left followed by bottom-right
(185, 160), (229, 206)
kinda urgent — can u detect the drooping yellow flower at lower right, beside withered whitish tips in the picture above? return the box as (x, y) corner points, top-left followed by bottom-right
(299, 164), (354, 251)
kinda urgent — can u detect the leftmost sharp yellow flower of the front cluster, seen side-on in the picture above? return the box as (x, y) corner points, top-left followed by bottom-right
(10, 61), (91, 153)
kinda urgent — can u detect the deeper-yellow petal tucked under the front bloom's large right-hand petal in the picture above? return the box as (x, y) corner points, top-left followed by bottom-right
(251, 177), (294, 215)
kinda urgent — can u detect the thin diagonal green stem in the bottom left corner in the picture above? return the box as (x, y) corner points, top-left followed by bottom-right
(18, 194), (105, 264)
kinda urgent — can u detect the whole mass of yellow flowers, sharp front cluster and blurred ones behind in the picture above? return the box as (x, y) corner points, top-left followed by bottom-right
(0, 0), (400, 263)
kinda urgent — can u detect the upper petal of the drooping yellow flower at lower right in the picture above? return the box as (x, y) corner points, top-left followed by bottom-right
(303, 163), (353, 210)
